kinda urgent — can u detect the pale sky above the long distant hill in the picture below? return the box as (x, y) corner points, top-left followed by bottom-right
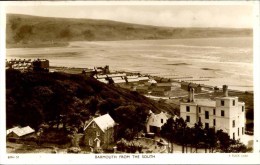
(6, 2), (253, 28)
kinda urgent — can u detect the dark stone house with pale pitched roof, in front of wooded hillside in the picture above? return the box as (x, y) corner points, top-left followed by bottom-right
(84, 114), (116, 148)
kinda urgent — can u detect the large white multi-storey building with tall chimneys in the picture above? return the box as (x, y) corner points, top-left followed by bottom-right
(180, 85), (245, 140)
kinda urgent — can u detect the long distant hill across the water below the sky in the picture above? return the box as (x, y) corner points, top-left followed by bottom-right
(6, 14), (253, 47)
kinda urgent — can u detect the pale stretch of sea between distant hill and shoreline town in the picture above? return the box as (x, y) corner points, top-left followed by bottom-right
(6, 37), (253, 91)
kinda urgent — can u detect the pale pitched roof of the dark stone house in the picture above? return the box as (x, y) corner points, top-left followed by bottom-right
(84, 114), (116, 132)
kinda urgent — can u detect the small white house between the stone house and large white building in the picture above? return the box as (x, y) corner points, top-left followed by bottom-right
(146, 111), (170, 133)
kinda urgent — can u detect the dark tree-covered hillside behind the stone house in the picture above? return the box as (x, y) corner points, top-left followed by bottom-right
(6, 70), (177, 137)
